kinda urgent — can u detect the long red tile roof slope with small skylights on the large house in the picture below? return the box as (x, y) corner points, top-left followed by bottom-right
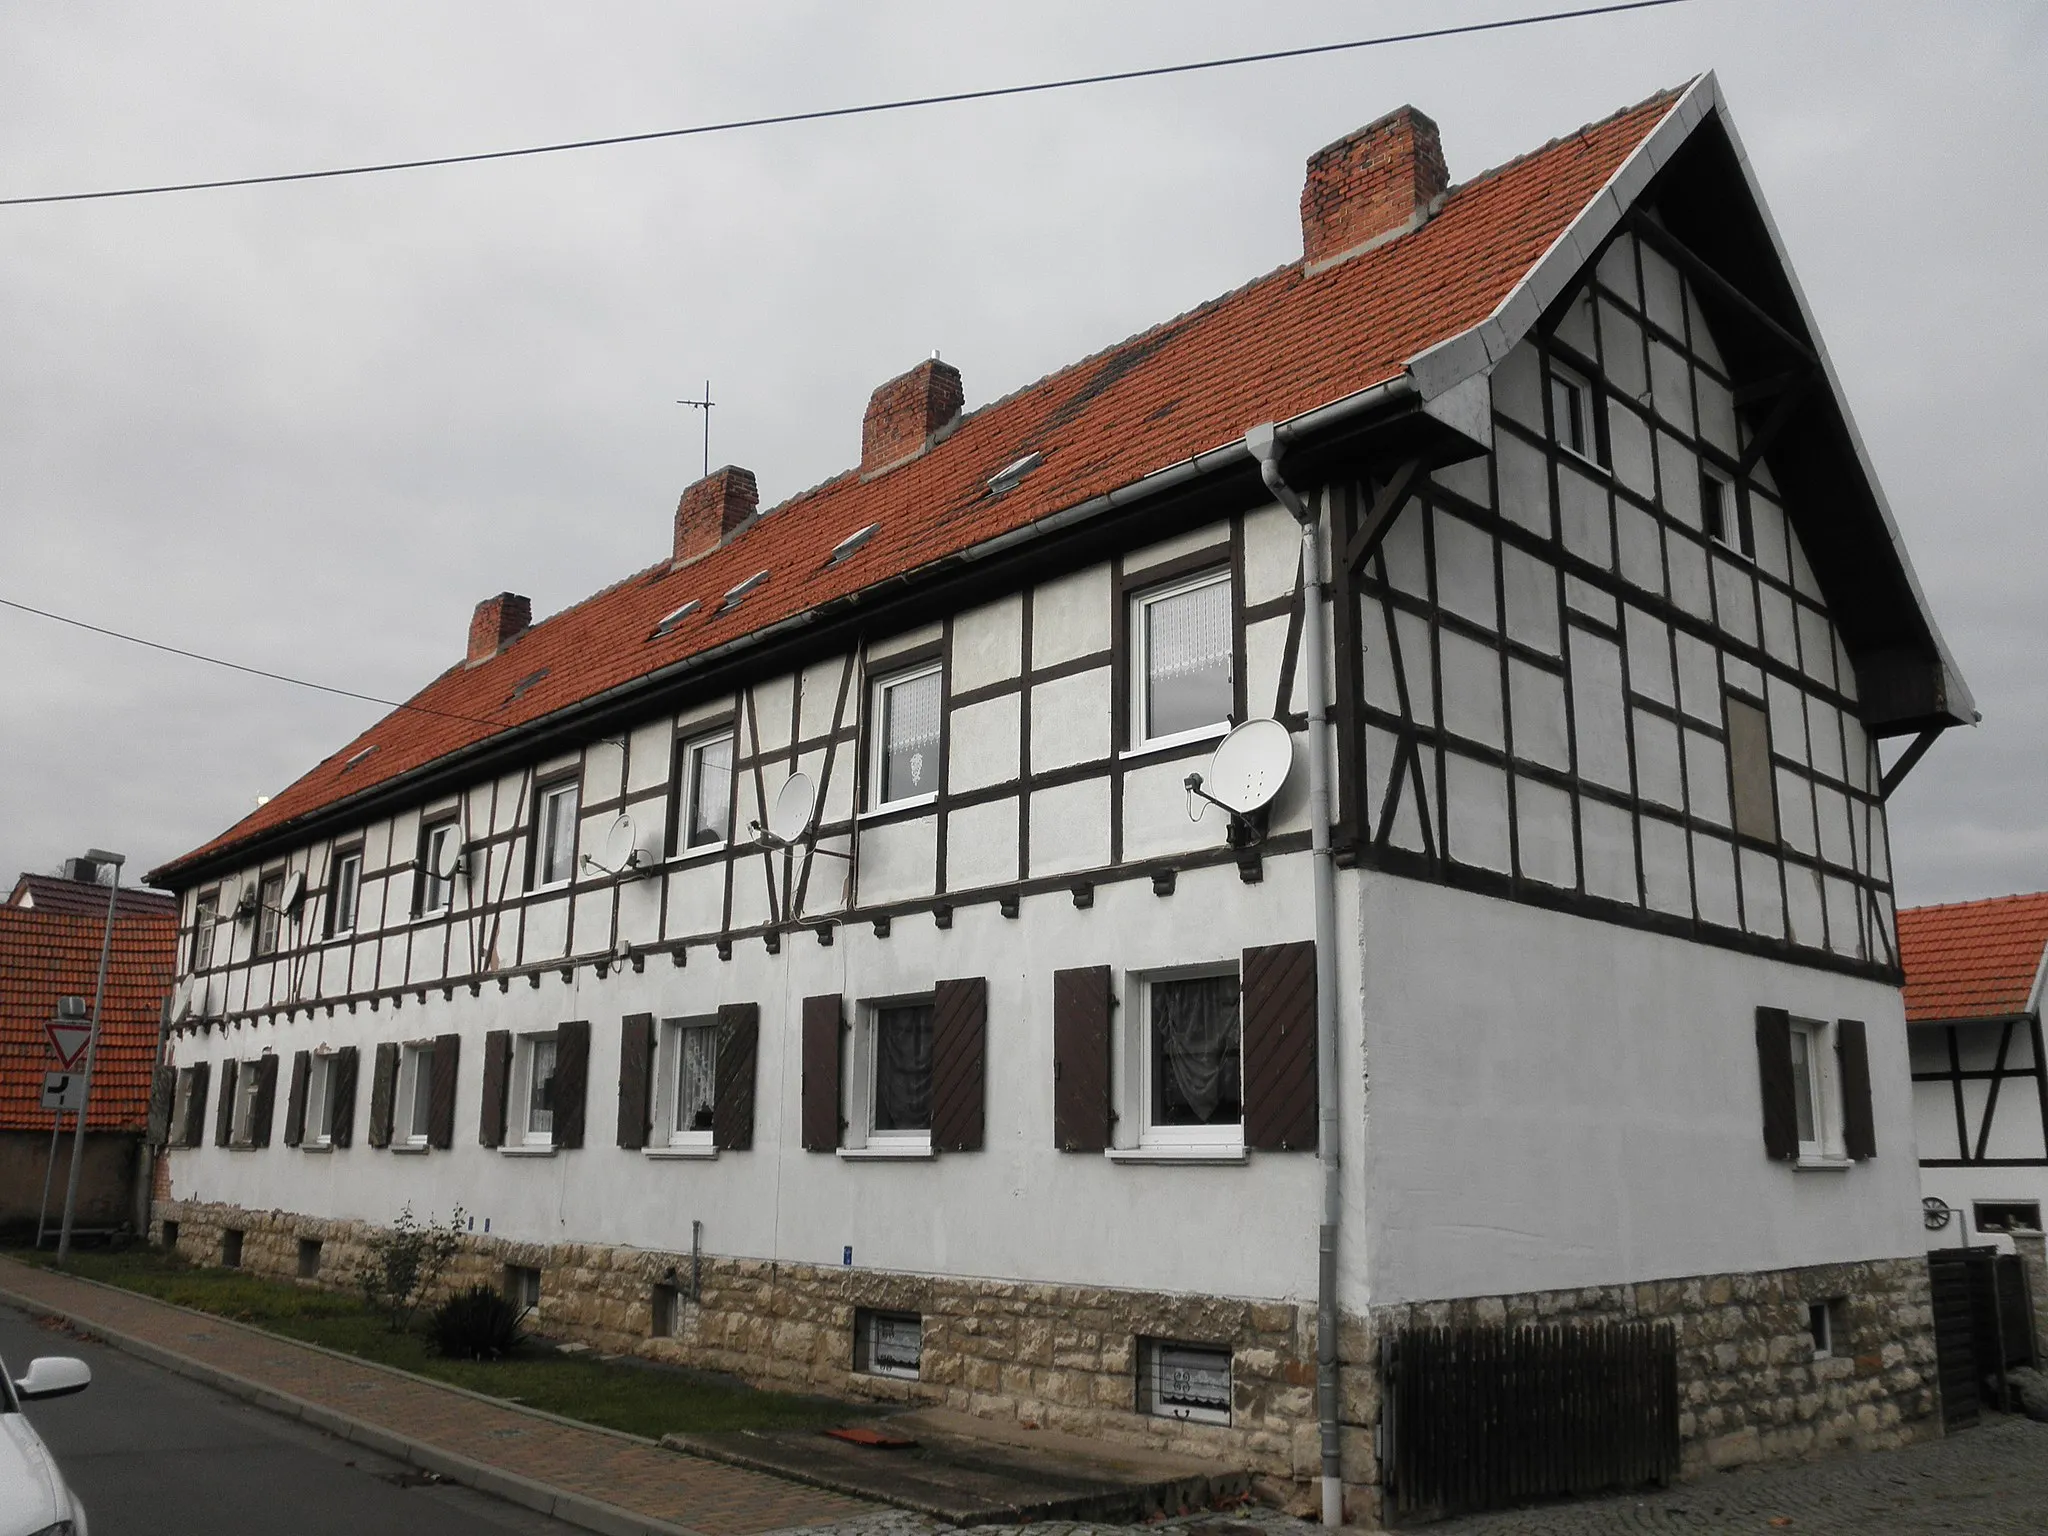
(150, 90), (1679, 883)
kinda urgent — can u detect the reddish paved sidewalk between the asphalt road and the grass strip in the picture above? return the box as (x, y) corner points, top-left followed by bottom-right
(0, 1260), (874, 1536)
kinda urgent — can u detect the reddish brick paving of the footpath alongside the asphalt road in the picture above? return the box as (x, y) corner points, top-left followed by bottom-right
(0, 1260), (874, 1536)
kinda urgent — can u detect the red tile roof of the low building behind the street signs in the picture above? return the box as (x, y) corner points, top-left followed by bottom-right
(0, 907), (178, 1130)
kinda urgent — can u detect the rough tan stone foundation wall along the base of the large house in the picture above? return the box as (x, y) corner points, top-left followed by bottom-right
(152, 1202), (1939, 1518)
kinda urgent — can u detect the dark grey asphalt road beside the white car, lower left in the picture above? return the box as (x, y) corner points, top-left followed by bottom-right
(0, 1307), (575, 1536)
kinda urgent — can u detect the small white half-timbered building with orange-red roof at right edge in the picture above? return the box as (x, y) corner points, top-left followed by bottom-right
(1898, 891), (2048, 1245)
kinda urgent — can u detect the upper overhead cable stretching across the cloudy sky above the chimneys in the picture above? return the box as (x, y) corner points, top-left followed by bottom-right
(0, 0), (1686, 207)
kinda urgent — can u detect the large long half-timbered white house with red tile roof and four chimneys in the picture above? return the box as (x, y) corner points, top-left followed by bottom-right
(140, 76), (1972, 1523)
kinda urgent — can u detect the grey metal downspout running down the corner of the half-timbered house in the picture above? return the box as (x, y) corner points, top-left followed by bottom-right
(1245, 424), (1343, 1526)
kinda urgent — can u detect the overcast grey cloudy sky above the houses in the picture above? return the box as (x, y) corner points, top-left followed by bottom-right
(0, 0), (2048, 901)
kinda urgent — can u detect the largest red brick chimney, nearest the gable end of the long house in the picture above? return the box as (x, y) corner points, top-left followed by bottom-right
(1300, 106), (1450, 270)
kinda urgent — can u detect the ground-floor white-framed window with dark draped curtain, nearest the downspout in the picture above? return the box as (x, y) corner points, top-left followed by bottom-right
(1120, 965), (1245, 1153)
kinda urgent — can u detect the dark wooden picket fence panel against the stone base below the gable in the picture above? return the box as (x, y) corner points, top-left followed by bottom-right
(1380, 1323), (1677, 1520)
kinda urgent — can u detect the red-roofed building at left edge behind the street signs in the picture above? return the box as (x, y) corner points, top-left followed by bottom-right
(0, 870), (178, 1233)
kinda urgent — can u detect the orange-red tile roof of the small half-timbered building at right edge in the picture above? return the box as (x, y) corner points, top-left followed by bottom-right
(1898, 891), (2048, 1024)
